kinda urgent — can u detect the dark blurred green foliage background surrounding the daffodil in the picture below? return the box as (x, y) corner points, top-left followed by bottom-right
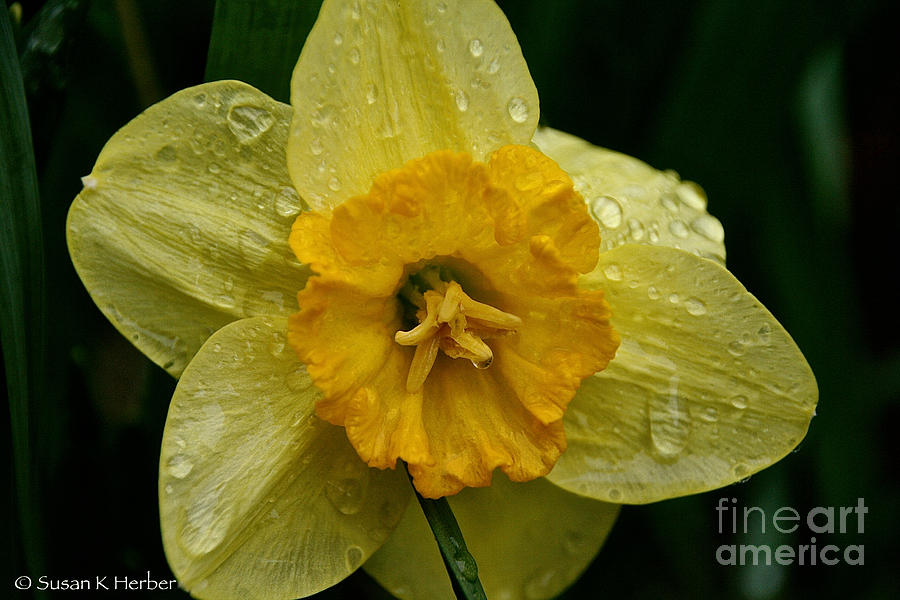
(3, 0), (900, 600)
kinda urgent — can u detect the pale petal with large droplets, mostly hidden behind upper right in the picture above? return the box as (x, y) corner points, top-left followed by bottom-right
(534, 128), (725, 264)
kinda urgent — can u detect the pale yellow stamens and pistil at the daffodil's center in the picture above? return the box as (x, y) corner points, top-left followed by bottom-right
(394, 266), (522, 393)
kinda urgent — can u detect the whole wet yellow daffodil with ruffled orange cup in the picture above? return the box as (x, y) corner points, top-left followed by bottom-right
(68, 0), (817, 598)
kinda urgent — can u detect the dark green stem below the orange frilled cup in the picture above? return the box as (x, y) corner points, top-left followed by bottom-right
(407, 471), (487, 600)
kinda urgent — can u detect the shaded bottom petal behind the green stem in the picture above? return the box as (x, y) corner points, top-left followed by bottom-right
(364, 476), (619, 600)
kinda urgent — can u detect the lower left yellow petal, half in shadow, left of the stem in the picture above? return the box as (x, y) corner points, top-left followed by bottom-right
(159, 317), (409, 599)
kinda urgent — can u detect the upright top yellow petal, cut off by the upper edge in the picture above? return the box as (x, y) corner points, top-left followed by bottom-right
(288, 0), (538, 208)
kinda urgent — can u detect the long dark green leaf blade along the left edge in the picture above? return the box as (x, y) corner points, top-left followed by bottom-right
(0, 7), (46, 573)
